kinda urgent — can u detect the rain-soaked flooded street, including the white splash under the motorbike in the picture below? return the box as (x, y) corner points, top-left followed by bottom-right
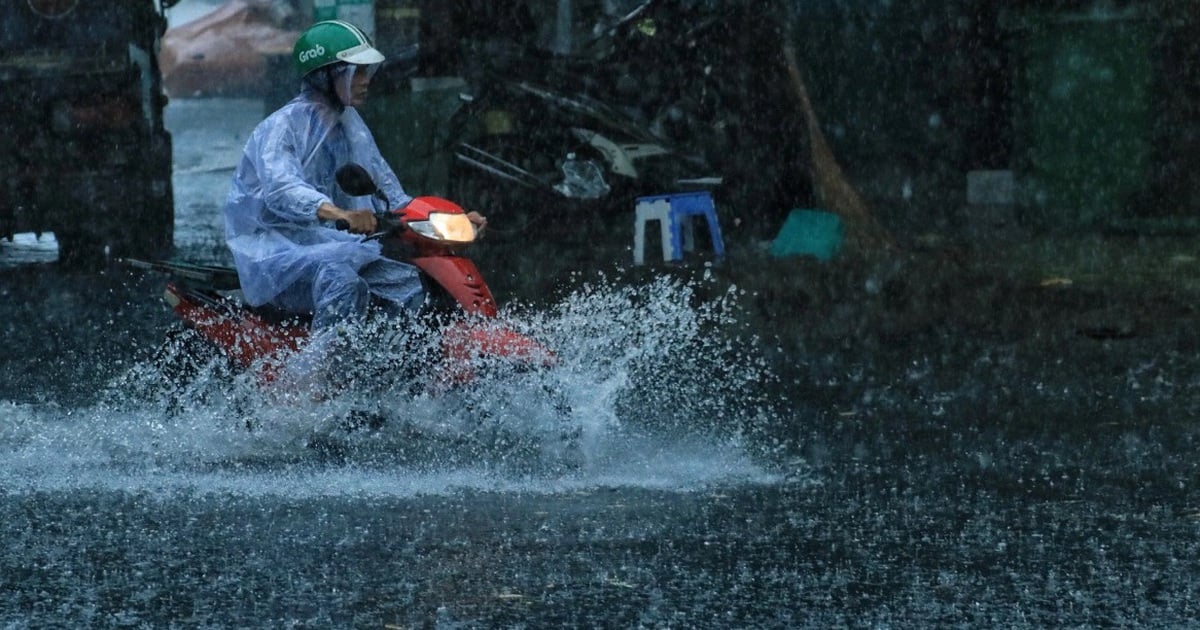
(0, 100), (1200, 628)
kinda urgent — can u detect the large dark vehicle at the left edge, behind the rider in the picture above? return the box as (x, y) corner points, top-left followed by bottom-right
(0, 0), (175, 265)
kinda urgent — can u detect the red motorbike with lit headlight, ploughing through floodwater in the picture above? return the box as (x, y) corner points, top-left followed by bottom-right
(126, 164), (554, 389)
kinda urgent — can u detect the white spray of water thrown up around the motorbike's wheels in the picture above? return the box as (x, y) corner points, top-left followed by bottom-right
(0, 272), (775, 496)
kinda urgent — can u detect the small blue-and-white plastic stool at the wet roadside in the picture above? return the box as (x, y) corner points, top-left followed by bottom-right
(634, 191), (725, 265)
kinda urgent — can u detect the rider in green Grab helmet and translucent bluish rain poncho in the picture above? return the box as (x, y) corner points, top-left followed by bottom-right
(224, 20), (486, 330)
